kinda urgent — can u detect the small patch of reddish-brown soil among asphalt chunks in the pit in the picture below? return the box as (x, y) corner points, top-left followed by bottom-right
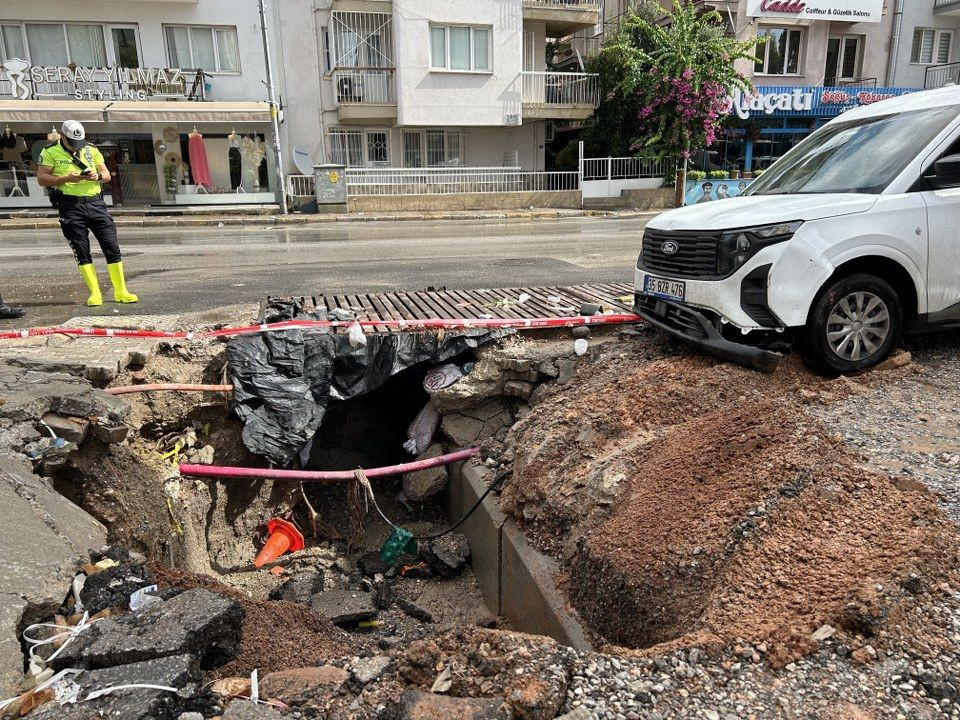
(151, 564), (353, 678)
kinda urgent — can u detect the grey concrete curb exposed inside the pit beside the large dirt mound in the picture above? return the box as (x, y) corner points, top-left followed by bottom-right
(448, 464), (593, 650)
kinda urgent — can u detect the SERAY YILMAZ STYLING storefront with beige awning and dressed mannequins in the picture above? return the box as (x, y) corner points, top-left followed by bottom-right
(0, 60), (277, 208)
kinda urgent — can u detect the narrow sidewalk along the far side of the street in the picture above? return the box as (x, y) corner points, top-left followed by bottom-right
(0, 208), (657, 231)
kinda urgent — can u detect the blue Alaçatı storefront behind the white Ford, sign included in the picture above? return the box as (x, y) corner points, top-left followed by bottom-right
(709, 86), (920, 173)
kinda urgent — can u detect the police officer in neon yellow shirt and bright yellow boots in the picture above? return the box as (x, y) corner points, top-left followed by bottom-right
(37, 120), (137, 307)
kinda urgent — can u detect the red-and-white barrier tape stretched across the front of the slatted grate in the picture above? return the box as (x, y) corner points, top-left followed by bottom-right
(0, 313), (641, 340)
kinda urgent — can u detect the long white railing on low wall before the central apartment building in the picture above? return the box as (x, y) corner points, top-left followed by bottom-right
(287, 167), (580, 199)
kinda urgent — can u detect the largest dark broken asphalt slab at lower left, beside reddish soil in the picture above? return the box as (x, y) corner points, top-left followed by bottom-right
(54, 590), (245, 669)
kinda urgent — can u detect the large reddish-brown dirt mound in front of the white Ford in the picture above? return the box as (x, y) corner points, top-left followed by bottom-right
(503, 342), (960, 664)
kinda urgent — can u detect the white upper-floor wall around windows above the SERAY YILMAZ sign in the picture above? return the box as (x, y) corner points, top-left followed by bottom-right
(0, 0), (267, 100)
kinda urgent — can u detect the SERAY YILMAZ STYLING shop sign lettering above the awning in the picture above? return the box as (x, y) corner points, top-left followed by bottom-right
(0, 58), (188, 100)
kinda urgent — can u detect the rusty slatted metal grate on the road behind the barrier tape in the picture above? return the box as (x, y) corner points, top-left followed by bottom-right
(260, 283), (633, 332)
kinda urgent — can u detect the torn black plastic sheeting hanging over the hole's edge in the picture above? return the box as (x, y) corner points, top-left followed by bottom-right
(227, 328), (515, 466)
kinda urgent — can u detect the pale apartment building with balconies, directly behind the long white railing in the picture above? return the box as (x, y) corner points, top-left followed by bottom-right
(276, 0), (601, 170)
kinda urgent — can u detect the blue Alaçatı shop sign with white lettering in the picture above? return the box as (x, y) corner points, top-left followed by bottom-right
(727, 86), (919, 120)
